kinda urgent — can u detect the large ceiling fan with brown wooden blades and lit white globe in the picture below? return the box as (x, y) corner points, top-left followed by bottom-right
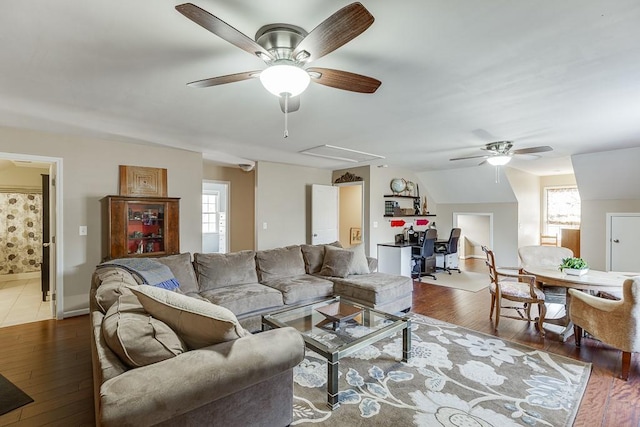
(176, 3), (381, 137)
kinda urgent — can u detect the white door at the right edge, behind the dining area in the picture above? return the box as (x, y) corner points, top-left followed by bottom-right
(609, 214), (640, 273)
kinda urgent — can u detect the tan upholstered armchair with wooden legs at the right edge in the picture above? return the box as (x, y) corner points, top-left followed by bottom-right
(569, 276), (640, 380)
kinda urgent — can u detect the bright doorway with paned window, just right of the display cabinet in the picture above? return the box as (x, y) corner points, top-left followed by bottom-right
(202, 180), (231, 254)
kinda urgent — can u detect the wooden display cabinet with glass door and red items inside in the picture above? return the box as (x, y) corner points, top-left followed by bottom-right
(101, 196), (180, 260)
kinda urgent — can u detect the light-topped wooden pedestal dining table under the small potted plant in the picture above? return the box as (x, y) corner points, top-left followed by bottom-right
(523, 266), (631, 341)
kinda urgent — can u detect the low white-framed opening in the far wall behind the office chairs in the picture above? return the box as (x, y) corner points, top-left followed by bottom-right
(453, 212), (493, 259)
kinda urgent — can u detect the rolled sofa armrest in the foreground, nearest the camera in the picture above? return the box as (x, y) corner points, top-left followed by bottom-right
(96, 328), (305, 427)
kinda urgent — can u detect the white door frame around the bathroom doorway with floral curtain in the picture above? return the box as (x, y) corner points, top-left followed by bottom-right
(0, 152), (64, 319)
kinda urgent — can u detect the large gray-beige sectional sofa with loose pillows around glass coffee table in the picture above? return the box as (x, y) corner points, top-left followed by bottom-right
(90, 243), (413, 426)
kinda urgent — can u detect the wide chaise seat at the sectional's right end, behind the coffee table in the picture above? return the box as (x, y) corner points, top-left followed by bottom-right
(331, 273), (413, 305)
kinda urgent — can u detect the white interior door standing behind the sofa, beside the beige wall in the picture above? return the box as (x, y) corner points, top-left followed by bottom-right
(311, 184), (339, 245)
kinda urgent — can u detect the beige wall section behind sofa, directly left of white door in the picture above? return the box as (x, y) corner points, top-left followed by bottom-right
(255, 162), (331, 250)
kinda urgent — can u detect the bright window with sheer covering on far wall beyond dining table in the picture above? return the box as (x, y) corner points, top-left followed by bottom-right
(544, 187), (580, 236)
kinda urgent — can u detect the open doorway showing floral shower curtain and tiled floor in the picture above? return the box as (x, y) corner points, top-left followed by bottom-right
(0, 153), (64, 326)
